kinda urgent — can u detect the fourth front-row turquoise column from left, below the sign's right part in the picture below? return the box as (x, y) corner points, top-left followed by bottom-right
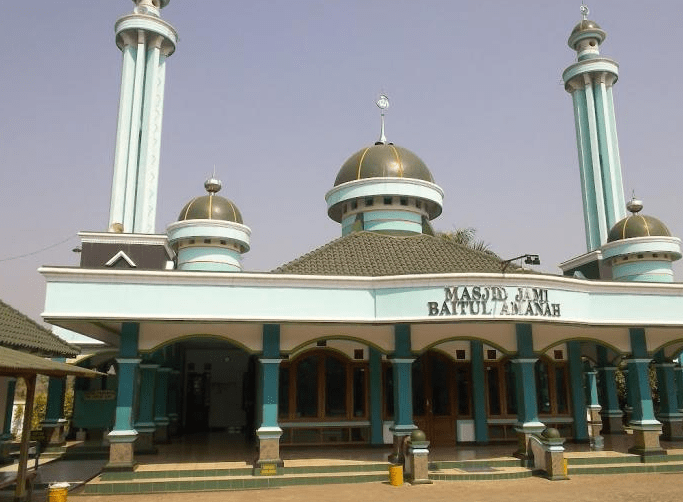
(512, 323), (545, 458)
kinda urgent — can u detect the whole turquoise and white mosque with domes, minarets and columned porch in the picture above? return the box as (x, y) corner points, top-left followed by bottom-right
(34, 0), (683, 476)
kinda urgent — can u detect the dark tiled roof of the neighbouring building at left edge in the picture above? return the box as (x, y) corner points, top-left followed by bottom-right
(0, 300), (79, 356)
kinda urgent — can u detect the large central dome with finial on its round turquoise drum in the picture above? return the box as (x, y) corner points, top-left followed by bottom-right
(325, 95), (443, 235)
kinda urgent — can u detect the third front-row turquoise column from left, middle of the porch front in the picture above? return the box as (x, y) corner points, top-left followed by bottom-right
(391, 324), (416, 446)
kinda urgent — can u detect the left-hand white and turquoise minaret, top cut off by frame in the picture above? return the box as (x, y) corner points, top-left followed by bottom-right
(109, 0), (178, 234)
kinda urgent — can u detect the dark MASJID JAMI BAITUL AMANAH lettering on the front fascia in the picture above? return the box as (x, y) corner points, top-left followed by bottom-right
(427, 286), (560, 317)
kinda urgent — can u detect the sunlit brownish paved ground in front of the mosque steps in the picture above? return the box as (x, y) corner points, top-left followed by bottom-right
(69, 473), (683, 502)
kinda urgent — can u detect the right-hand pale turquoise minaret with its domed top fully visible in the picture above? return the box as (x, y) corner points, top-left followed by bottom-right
(562, 5), (626, 252)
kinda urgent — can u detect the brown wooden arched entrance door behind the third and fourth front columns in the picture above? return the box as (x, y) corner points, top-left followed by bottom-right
(413, 351), (471, 445)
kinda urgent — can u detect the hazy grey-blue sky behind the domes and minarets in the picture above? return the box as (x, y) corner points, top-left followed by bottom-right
(0, 0), (683, 320)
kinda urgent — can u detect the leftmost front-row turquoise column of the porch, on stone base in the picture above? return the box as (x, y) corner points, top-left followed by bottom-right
(105, 322), (140, 470)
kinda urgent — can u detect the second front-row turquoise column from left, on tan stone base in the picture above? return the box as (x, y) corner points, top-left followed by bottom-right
(254, 324), (283, 475)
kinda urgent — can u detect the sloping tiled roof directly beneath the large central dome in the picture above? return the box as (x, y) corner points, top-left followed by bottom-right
(273, 231), (510, 277)
